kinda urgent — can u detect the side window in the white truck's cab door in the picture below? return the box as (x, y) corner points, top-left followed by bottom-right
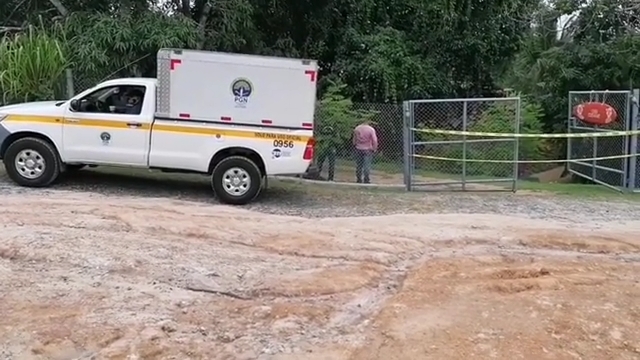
(78, 85), (146, 115)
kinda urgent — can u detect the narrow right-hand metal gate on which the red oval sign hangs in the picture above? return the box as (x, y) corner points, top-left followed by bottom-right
(567, 90), (638, 190)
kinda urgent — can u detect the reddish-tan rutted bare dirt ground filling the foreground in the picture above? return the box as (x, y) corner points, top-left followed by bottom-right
(0, 191), (640, 360)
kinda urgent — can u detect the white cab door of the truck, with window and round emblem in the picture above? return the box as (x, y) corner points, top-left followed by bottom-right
(60, 79), (156, 167)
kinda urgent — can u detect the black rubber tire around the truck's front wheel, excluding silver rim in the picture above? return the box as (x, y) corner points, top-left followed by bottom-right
(4, 137), (60, 187)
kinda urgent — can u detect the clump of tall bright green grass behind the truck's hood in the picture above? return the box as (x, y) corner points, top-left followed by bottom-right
(0, 22), (70, 104)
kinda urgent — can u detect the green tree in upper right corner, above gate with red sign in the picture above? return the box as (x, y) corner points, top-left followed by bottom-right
(503, 0), (640, 131)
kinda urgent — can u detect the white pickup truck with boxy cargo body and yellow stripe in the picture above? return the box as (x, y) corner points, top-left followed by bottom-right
(0, 49), (318, 205)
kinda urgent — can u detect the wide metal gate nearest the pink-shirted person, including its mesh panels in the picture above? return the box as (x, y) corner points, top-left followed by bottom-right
(403, 97), (520, 191)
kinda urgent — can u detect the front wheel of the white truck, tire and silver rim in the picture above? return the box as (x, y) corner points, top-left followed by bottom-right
(4, 137), (60, 187)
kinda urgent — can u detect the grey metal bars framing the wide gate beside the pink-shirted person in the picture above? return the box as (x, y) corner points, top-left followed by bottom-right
(402, 96), (522, 192)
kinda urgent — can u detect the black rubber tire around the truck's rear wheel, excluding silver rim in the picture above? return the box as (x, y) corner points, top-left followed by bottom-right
(211, 156), (262, 205)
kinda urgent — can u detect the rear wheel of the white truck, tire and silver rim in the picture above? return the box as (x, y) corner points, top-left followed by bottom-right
(211, 156), (262, 205)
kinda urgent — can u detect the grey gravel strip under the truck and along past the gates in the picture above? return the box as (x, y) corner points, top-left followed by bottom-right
(0, 168), (640, 222)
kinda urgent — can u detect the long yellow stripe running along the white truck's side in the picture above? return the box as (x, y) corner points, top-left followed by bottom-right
(4, 115), (311, 143)
